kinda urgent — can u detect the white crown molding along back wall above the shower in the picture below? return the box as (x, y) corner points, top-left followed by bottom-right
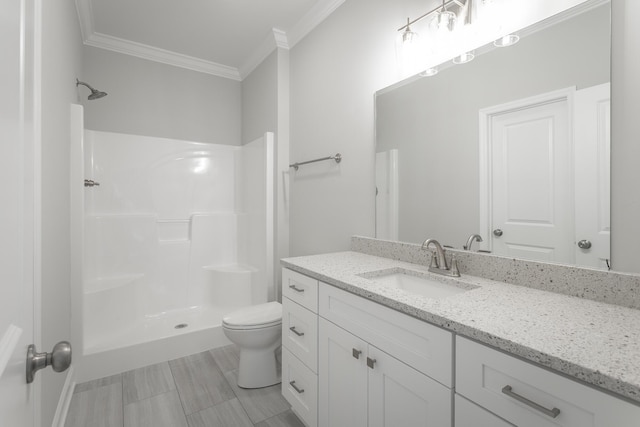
(84, 32), (241, 81)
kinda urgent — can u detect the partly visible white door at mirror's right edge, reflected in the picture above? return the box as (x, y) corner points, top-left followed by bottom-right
(574, 83), (611, 269)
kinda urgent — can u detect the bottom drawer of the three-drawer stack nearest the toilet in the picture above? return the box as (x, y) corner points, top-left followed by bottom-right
(282, 347), (318, 427)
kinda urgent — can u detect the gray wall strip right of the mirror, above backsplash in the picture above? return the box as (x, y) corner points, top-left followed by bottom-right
(611, 0), (640, 273)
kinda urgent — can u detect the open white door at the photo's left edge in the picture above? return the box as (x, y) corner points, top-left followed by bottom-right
(0, 0), (37, 427)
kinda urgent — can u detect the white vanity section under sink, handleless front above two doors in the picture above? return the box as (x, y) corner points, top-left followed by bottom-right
(318, 283), (453, 427)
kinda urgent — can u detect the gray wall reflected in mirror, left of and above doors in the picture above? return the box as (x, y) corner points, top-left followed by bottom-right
(376, 5), (610, 249)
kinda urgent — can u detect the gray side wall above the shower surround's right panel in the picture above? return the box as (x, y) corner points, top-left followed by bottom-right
(242, 50), (278, 144)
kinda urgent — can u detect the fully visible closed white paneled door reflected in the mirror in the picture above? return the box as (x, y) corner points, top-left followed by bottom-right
(481, 92), (575, 263)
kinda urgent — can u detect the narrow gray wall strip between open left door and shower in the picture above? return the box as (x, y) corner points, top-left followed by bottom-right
(41, 0), (82, 426)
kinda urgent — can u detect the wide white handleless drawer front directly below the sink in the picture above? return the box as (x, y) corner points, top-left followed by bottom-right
(319, 283), (453, 388)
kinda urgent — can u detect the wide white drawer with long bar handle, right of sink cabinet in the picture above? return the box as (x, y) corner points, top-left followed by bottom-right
(456, 337), (640, 427)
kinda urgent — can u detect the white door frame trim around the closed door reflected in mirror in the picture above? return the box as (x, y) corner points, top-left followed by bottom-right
(478, 86), (576, 251)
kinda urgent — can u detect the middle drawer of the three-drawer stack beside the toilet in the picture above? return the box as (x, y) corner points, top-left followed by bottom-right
(282, 297), (318, 373)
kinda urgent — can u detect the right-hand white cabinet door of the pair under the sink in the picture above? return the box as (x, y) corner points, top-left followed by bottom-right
(368, 345), (453, 427)
